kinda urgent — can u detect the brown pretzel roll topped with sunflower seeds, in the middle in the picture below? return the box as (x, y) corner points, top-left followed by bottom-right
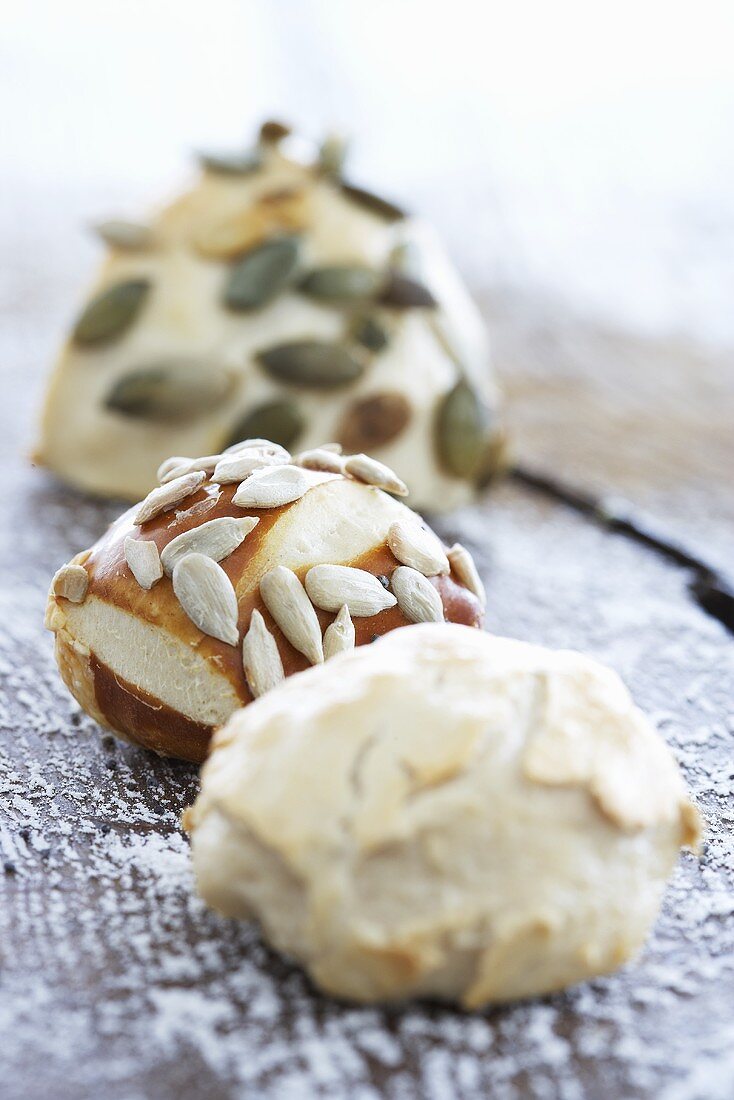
(46, 440), (483, 761)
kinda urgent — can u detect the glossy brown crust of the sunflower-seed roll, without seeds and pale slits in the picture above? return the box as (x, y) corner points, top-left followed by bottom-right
(46, 482), (481, 762)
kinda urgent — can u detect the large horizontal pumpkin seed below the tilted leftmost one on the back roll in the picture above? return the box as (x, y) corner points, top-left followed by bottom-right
(105, 361), (232, 424)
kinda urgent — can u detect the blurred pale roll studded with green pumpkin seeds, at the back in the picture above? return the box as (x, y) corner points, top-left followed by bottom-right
(36, 118), (501, 510)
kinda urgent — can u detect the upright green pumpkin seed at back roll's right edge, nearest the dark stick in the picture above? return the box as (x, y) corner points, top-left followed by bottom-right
(436, 380), (497, 481)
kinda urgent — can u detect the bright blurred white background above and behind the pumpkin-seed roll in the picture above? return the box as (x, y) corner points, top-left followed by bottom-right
(0, 0), (734, 345)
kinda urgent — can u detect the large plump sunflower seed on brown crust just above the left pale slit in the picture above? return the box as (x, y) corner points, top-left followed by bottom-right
(173, 553), (240, 646)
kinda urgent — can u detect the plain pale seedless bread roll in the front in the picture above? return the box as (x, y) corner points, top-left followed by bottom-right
(186, 625), (699, 1009)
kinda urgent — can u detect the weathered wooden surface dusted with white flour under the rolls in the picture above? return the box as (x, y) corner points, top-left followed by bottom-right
(0, 264), (734, 1100)
